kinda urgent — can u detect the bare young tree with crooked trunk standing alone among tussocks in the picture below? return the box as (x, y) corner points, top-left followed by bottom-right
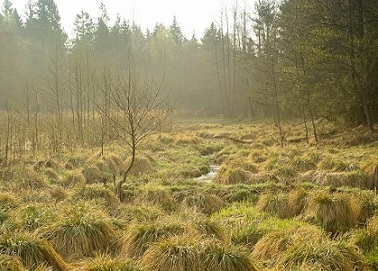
(100, 65), (167, 200)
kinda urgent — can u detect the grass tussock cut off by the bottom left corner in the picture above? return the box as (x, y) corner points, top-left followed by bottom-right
(0, 232), (68, 271)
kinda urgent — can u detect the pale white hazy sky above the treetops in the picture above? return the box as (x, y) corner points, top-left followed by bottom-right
(9, 0), (253, 38)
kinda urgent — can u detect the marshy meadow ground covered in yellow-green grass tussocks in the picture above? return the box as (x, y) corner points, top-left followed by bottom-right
(0, 120), (378, 271)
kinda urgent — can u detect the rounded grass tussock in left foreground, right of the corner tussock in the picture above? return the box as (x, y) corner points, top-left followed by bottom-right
(45, 205), (115, 258)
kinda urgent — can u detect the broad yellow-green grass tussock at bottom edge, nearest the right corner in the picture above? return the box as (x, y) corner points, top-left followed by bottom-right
(252, 226), (369, 271)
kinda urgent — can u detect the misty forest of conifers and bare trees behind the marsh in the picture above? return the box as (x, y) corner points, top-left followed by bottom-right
(0, 0), (378, 157)
